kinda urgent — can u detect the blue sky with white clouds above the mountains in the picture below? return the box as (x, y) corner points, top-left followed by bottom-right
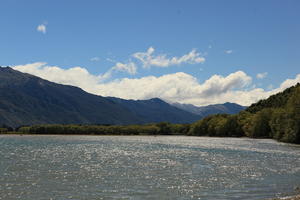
(0, 0), (300, 106)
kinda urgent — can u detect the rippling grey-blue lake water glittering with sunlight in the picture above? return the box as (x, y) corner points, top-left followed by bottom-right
(0, 136), (300, 200)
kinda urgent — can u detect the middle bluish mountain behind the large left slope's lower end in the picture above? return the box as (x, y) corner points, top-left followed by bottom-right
(108, 97), (201, 123)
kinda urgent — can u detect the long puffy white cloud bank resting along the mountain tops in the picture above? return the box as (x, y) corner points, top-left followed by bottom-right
(13, 62), (300, 106)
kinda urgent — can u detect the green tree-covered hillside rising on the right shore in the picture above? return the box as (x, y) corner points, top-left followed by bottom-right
(188, 83), (300, 144)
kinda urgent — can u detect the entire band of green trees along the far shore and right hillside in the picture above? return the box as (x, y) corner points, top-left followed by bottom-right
(0, 83), (300, 144)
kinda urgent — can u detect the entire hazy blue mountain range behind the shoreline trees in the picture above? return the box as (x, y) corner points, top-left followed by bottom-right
(0, 67), (245, 127)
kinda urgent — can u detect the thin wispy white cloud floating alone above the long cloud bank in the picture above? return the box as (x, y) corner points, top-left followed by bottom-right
(132, 47), (205, 68)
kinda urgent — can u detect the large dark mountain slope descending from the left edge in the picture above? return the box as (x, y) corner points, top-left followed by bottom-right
(0, 67), (144, 127)
